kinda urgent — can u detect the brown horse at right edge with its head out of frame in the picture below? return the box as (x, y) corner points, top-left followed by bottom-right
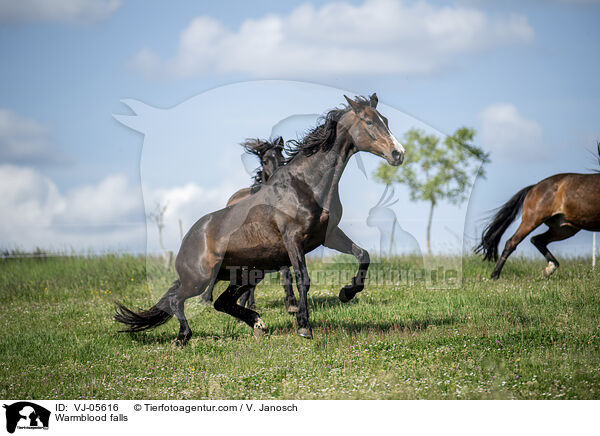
(475, 158), (600, 280)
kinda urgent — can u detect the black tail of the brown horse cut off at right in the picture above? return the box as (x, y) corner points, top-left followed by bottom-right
(475, 185), (534, 261)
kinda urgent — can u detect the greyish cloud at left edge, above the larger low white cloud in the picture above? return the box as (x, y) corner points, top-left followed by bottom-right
(0, 109), (64, 164)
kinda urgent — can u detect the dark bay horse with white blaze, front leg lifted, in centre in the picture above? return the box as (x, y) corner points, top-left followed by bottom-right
(115, 94), (404, 344)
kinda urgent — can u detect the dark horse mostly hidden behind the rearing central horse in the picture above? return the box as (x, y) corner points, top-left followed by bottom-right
(224, 136), (298, 313)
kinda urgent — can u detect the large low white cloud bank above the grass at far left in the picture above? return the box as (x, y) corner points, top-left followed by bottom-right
(0, 165), (145, 250)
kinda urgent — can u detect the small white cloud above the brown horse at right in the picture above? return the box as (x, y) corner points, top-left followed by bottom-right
(481, 103), (545, 159)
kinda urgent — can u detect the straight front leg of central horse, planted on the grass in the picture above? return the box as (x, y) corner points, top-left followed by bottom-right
(283, 234), (312, 339)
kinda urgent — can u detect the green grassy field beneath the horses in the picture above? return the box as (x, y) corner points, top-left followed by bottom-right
(0, 256), (600, 399)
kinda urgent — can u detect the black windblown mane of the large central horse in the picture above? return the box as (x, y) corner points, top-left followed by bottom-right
(284, 96), (370, 165)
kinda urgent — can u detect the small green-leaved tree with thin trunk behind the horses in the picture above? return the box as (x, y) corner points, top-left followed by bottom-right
(375, 127), (490, 255)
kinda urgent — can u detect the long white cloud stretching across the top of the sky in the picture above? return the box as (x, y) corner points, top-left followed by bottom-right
(131, 0), (534, 77)
